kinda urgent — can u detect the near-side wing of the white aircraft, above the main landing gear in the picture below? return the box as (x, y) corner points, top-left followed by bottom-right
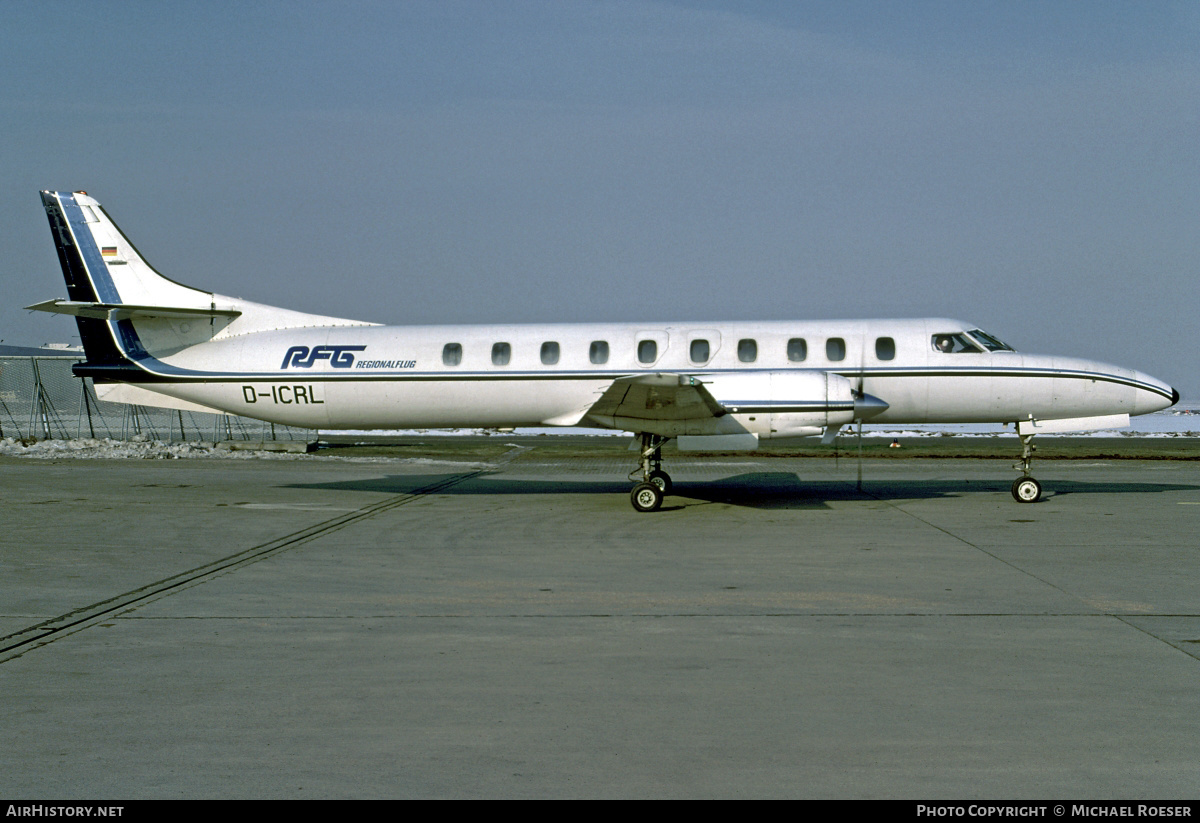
(586, 374), (728, 422)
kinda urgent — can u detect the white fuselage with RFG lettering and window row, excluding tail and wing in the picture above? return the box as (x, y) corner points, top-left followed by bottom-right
(131, 319), (1171, 438)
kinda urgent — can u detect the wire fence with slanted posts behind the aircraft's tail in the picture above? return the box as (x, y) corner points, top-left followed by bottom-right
(0, 356), (317, 441)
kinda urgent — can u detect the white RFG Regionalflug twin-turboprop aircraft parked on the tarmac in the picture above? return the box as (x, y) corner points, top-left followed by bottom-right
(29, 192), (1180, 511)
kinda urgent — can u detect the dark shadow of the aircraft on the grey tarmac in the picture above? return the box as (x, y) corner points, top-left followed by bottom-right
(286, 471), (1200, 509)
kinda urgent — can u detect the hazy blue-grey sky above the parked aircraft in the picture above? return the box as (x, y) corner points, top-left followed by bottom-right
(0, 0), (1200, 401)
